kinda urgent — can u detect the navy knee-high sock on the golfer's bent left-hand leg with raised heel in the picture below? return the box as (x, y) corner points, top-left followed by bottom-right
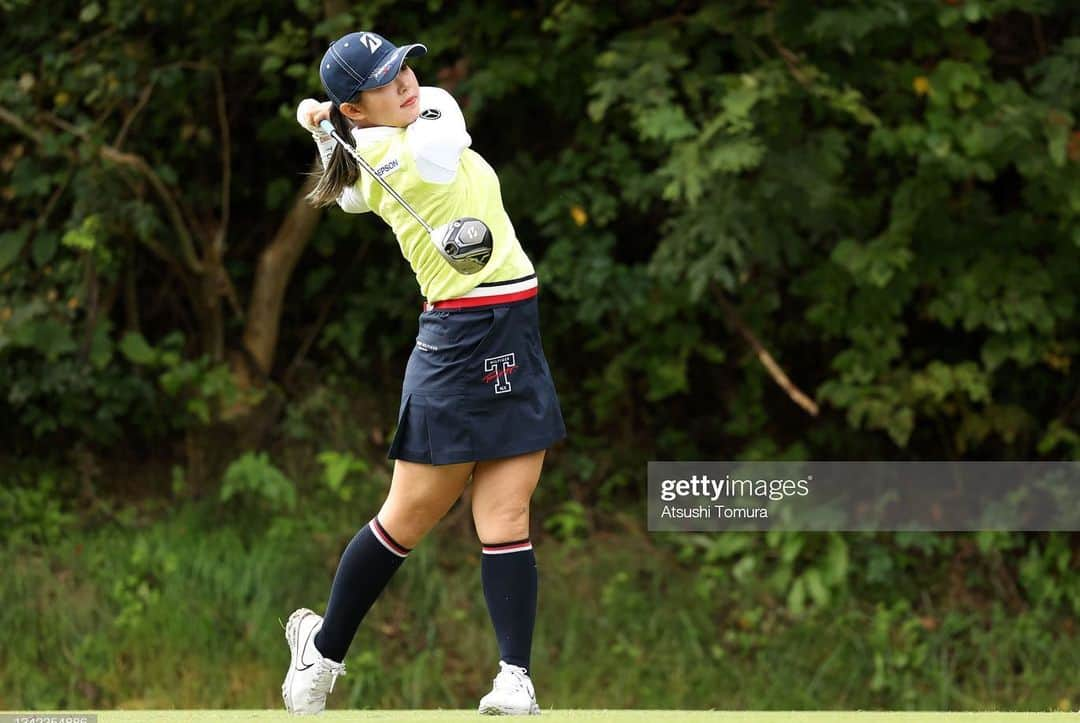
(315, 517), (411, 662)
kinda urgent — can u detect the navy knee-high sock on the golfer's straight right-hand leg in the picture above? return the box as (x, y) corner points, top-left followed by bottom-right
(481, 538), (538, 670)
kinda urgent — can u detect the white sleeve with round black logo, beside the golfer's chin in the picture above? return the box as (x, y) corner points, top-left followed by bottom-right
(405, 85), (472, 184)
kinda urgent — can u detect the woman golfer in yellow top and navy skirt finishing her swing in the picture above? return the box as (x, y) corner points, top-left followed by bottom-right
(282, 32), (566, 714)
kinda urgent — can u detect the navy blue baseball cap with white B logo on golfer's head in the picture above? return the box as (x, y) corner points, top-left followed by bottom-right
(319, 32), (428, 106)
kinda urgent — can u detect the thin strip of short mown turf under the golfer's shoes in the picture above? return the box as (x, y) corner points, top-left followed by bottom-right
(8, 710), (1077, 723)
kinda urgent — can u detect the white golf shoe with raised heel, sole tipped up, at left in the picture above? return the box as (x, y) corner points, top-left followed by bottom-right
(281, 607), (345, 715)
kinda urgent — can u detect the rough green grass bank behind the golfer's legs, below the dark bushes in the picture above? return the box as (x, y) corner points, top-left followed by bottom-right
(0, 501), (1080, 708)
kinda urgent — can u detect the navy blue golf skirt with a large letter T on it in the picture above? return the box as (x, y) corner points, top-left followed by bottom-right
(387, 296), (566, 465)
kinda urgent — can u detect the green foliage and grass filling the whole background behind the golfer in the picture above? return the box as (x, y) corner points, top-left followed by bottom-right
(0, 0), (1080, 709)
